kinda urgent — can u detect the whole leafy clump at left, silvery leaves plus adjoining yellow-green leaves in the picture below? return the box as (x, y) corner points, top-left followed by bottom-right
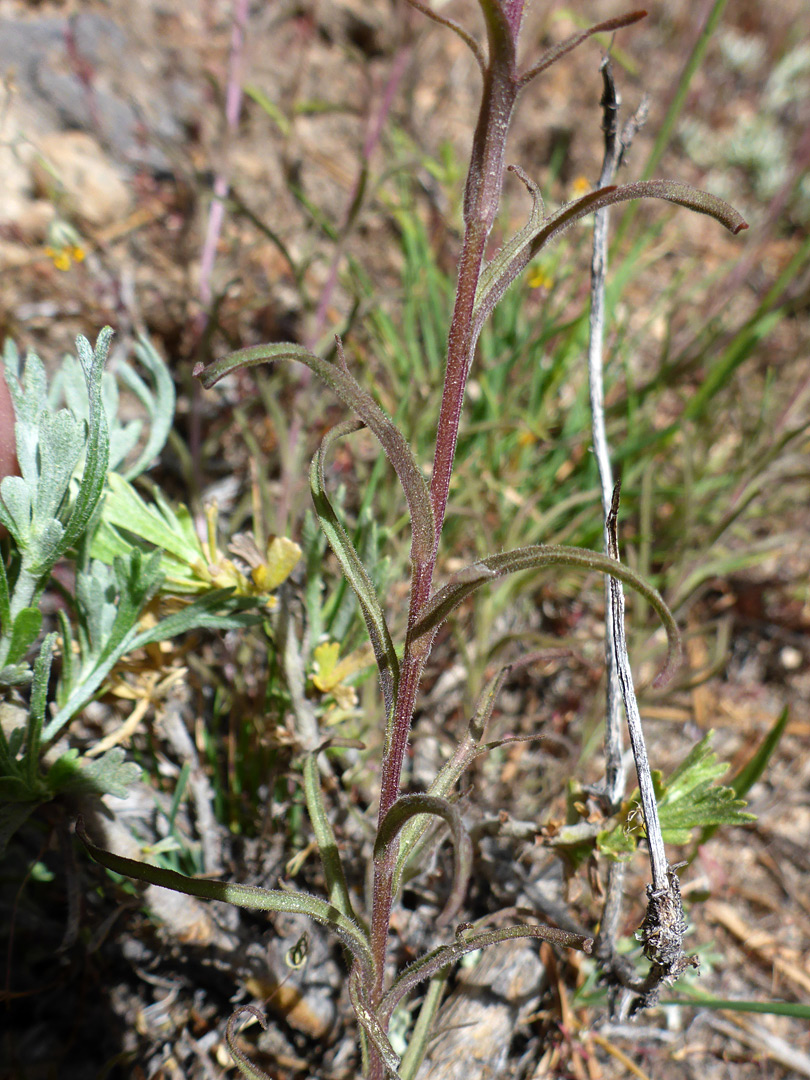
(0, 328), (300, 852)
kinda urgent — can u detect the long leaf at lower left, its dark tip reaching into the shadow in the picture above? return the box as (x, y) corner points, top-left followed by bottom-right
(76, 816), (374, 980)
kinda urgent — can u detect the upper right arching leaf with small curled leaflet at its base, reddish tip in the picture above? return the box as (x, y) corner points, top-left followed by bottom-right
(473, 179), (748, 342)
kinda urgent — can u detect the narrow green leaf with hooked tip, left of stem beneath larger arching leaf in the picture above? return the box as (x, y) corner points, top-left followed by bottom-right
(309, 420), (400, 716)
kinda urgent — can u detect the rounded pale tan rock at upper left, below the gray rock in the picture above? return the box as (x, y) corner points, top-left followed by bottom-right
(31, 132), (133, 228)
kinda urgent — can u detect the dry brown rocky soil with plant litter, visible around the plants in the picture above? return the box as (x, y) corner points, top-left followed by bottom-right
(0, 0), (810, 1080)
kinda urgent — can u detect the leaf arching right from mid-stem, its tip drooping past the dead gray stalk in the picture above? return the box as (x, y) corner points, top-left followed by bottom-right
(408, 544), (680, 683)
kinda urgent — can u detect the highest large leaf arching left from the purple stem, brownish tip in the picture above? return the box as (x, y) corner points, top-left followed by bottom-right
(194, 342), (435, 567)
